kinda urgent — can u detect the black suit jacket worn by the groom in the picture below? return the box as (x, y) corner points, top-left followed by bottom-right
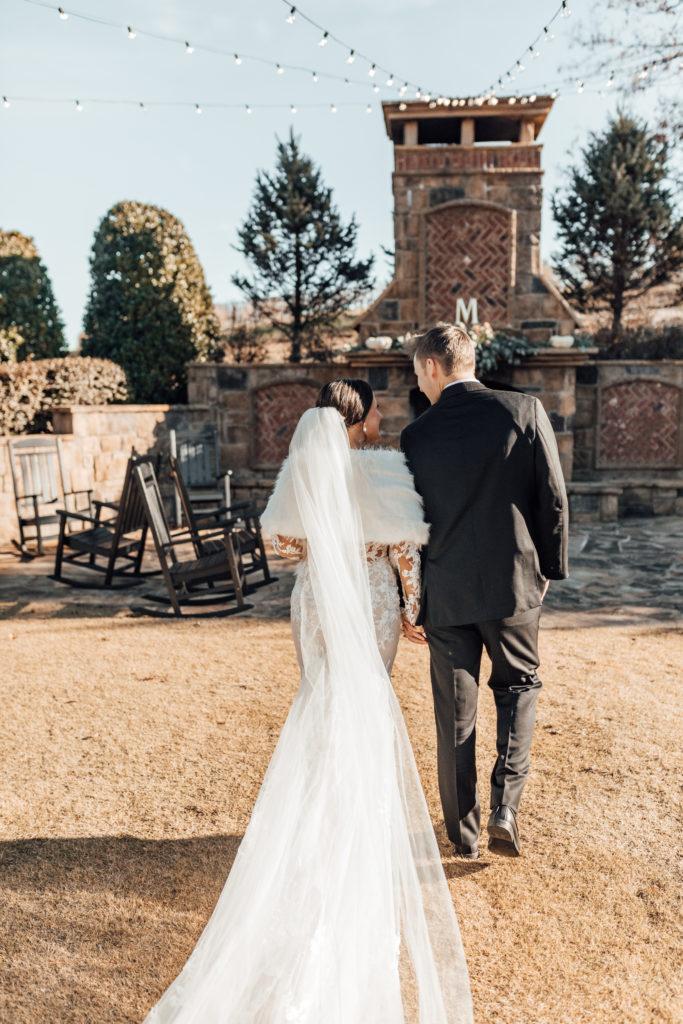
(400, 381), (567, 626)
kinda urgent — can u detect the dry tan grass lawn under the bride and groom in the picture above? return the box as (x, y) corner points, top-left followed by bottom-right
(0, 615), (683, 1024)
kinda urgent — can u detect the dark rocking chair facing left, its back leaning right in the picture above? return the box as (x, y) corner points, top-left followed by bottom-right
(53, 453), (155, 588)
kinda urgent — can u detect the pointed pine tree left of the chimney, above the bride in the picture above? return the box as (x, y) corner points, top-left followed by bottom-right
(232, 132), (373, 362)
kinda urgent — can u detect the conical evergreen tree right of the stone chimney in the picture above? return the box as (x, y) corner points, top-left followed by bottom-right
(552, 114), (683, 339)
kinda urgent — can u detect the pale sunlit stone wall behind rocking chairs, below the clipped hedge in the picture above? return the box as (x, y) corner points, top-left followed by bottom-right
(0, 404), (211, 546)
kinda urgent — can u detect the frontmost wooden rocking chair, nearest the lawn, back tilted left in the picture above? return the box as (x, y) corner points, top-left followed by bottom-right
(133, 461), (253, 617)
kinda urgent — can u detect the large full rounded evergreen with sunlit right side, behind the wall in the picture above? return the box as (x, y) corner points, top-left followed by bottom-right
(83, 202), (219, 401)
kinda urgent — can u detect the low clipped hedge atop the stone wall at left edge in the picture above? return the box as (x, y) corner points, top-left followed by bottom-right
(0, 355), (128, 434)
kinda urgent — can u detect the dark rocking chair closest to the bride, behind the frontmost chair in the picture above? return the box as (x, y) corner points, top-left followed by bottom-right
(169, 455), (278, 586)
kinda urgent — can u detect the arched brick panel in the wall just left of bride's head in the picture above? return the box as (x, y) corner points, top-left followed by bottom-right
(254, 382), (318, 466)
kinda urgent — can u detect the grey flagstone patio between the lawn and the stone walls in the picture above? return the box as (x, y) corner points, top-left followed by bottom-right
(0, 517), (683, 628)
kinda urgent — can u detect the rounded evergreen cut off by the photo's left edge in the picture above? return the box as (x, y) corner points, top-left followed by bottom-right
(0, 231), (67, 361)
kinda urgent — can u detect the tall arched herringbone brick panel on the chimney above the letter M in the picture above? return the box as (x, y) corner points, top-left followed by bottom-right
(420, 200), (516, 324)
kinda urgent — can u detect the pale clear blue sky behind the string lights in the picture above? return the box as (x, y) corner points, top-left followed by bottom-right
(0, 0), (671, 346)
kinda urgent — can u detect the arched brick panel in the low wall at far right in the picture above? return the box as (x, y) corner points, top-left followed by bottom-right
(597, 380), (682, 469)
